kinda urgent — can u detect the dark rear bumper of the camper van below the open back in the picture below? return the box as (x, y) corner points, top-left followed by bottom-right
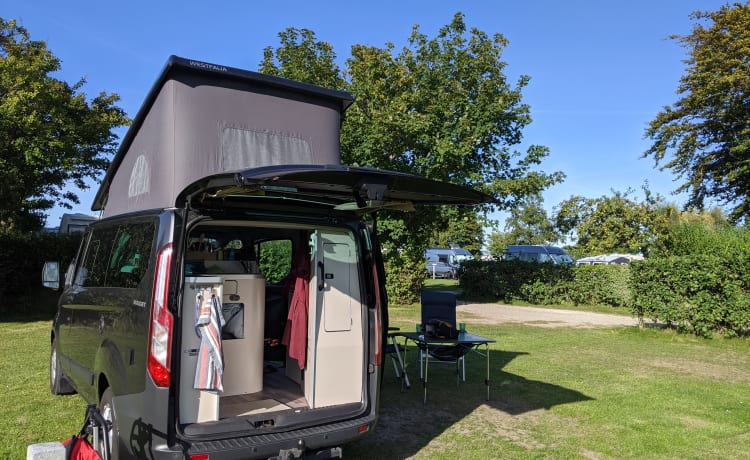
(154, 415), (377, 460)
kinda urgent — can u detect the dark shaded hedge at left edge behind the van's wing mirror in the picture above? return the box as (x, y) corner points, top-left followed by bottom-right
(0, 233), (82, 316)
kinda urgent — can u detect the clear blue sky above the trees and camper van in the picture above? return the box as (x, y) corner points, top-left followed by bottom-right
(0, 0), (726, 230)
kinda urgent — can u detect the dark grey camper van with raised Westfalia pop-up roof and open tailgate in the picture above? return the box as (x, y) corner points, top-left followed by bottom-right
(45, 56), (488, 460)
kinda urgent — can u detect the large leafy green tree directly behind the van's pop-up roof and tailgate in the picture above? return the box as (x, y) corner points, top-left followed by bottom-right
(260, 13), (564, 274)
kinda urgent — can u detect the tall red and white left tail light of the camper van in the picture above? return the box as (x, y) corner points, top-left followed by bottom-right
(148, 243), (172, 388)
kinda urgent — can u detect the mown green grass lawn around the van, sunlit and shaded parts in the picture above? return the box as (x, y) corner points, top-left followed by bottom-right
(0, 306), (750, 459)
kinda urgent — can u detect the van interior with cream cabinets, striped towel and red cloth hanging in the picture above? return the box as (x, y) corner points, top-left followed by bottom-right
(178, 221), (368, 433)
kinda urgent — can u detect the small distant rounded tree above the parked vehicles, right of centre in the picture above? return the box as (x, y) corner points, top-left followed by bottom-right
(555, 186), (664, 255)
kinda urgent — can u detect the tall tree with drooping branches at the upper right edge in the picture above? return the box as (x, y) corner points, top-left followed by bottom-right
(643, 3), (750, 221)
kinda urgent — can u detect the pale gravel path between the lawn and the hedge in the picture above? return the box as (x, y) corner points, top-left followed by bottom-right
(457, 302), (638, 328)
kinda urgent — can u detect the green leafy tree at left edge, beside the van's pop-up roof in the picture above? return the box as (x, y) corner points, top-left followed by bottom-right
(0, 18), (128, 233)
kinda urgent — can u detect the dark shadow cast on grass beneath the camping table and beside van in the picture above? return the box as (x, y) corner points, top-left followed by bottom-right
(343, 350), (592, 459)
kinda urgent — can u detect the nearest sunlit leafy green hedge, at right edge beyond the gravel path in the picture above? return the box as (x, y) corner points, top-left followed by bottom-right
(631, 255), (750, 337)
